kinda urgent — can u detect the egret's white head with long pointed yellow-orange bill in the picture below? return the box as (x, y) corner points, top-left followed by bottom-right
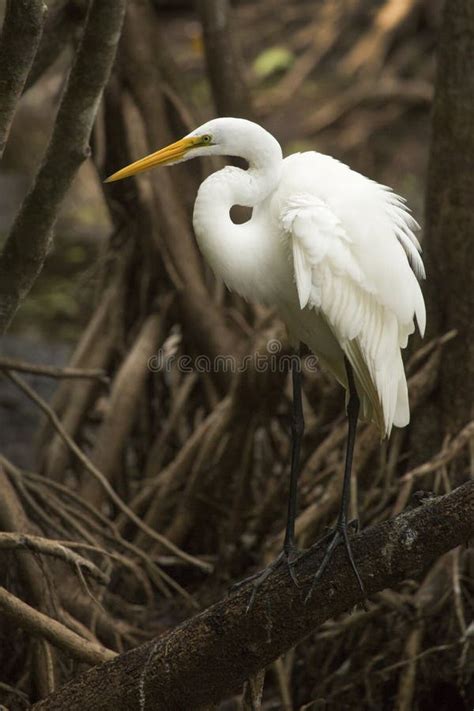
(105, 118), (276, 183)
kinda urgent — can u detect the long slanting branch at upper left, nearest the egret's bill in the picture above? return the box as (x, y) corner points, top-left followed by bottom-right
(0, 0), (125, 333)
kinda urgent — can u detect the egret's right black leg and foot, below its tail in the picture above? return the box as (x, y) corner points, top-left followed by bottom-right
(306, 358), (366, 601)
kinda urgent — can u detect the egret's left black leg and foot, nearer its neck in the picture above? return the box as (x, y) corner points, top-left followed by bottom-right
(233, 350), (304, 610)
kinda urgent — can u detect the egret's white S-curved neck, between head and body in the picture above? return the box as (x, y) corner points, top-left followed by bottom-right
(193, 132), (283, 296)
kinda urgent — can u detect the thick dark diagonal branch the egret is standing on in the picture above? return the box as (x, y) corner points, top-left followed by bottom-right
(35, 482), (474, 711)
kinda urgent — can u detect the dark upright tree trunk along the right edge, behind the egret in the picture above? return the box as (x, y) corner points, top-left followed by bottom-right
(425, 0), (474, 442)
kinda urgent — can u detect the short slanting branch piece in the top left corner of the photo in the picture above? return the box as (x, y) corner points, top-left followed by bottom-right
(0, 0), (46, 157)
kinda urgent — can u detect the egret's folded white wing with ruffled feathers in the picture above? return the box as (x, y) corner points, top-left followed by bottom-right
(280, 175), (425, 435)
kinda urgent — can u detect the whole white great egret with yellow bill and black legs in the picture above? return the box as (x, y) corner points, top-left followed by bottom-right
(108, 118), (426, 596)
